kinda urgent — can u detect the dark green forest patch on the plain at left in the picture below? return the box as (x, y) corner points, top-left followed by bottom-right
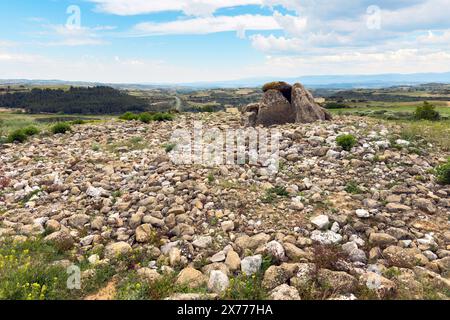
(0, 87), (148, 114)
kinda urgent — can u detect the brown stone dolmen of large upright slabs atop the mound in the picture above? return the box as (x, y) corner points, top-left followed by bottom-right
(242, 82), (332, 127)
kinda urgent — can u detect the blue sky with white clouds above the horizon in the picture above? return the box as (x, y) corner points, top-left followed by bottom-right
(0, 0), (450, 83)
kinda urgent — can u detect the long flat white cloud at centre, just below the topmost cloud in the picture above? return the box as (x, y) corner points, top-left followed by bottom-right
(132, 15), (281, 36)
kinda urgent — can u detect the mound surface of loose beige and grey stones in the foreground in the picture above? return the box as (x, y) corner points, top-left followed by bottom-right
(0, 113), (450, 299)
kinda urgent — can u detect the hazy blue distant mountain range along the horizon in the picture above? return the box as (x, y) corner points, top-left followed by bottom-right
(0, 72), (450, 90)
